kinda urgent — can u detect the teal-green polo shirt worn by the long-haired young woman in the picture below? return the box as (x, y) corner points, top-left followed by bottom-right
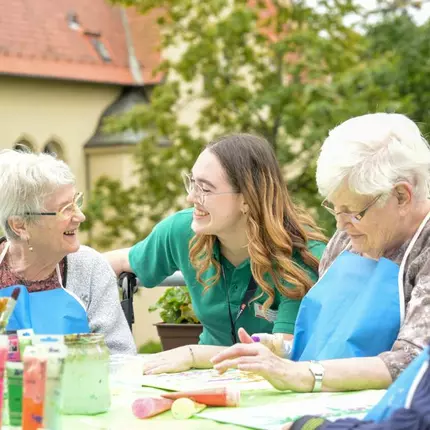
(129, 208), (325, 346)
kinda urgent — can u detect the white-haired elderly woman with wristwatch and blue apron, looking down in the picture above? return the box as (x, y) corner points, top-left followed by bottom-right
(212, 113), (430, 392)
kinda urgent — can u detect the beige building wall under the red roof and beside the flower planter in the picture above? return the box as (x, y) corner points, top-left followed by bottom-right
(0, 76), (164, 345)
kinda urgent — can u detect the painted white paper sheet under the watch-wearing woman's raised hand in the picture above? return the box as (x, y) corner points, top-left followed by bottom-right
(139, 369), (273, 391)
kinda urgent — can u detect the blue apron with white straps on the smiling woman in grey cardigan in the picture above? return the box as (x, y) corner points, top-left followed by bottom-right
(0, 243), (90, 334)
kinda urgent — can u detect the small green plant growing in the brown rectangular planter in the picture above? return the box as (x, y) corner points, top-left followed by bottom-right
(148, 287), (200, 324)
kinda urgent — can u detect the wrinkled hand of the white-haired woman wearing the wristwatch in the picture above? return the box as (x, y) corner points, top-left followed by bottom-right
(211, 343), (295, 390)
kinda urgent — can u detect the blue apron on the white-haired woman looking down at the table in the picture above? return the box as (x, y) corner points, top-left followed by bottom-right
(291, 251), (403, 361)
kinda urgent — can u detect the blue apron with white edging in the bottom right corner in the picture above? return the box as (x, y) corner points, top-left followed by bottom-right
(365, 347), (429, 422)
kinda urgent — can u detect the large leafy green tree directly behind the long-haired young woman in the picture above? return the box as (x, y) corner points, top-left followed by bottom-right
(83, 0), (420, 247)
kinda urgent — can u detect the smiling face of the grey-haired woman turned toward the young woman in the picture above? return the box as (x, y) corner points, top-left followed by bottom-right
(27, 185), (85, 260)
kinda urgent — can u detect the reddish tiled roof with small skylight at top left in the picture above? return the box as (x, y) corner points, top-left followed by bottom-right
(0, 0), (161, 85)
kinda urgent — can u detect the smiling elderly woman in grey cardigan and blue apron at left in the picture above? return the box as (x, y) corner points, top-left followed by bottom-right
(0, 150), (136, 353)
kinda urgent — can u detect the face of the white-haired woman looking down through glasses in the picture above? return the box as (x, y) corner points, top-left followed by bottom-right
(329, 183), (407, 258)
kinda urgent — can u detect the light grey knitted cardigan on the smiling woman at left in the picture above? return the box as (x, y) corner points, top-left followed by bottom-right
(64, 246), (136, 354)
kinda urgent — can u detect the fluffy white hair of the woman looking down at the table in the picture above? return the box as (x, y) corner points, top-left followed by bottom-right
(316, 113), (430, 200)
